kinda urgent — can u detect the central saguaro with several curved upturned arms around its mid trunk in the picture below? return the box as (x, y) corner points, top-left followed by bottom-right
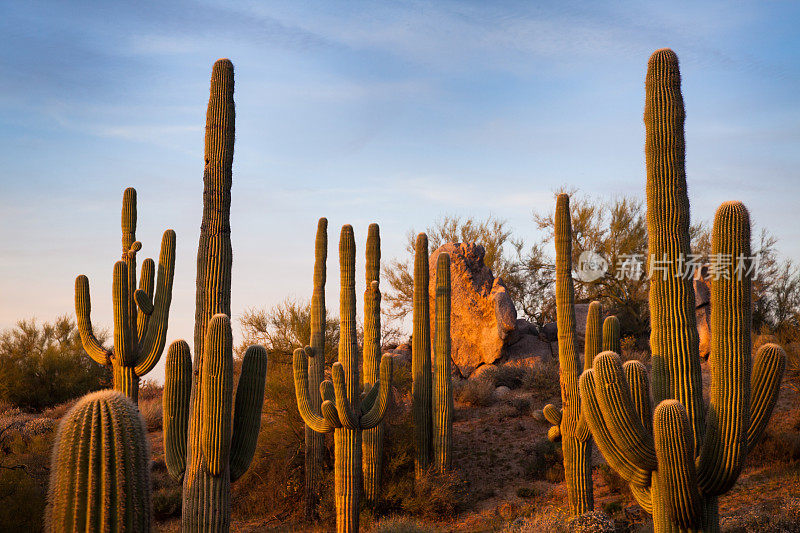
(293, 225), (392, 532)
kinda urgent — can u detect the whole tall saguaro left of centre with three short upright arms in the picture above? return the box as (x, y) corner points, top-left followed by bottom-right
(163, 59), (267, 532)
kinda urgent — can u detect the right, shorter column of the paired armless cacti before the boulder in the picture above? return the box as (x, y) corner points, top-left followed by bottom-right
(433, 253), (453, 472)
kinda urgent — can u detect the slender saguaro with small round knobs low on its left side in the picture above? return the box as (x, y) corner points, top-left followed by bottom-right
(542, 193), (600, 515)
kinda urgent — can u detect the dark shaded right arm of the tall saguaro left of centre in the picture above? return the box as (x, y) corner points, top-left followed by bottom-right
(230, 345), (267, 482)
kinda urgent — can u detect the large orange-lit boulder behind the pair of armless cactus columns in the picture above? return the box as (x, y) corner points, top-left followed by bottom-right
(430, 243), (517, 377)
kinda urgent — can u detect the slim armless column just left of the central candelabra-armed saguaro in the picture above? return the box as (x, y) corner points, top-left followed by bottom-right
(305, 217), (328, 520)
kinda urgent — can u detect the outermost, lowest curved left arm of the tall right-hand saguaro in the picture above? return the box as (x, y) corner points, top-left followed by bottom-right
(580, 367), (652, 487)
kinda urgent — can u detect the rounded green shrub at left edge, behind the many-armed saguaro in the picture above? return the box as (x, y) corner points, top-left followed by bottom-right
(0, 316), (111, 410)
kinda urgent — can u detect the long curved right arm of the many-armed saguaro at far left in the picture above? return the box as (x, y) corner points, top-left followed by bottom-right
(136, 229), (175, 376)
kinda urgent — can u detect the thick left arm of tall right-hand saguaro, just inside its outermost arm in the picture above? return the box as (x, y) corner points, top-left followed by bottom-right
(594, 352), (657, 470)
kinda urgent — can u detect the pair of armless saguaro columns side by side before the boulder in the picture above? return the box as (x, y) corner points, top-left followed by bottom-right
(411, 233), (453, 478)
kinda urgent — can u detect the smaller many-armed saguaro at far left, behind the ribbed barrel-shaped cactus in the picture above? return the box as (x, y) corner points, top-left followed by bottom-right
(75, 187), (175, 403)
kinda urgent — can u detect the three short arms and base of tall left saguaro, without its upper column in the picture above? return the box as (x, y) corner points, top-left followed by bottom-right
(163, 314), (267, 532)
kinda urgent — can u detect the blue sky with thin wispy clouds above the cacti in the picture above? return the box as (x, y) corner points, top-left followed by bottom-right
(0, 1), (800, 377)
